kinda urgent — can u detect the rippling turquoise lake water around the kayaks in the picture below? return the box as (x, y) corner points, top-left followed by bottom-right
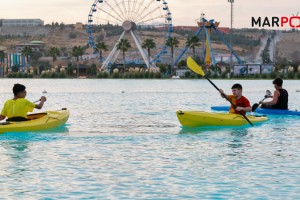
(0, 79), (300, 199)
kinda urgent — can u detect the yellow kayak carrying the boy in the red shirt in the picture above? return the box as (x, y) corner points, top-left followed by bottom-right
(176, 110), (268, 127)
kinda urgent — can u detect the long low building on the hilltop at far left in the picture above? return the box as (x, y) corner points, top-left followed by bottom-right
(0, 19), (44, 27)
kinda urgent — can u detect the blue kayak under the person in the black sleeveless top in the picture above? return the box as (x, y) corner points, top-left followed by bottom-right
(211, 106), (300, 116)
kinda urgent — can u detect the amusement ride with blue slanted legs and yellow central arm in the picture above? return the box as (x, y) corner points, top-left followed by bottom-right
(172, 13), (243, 67)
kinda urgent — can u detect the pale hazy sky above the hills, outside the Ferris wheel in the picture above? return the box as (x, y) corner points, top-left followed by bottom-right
(0, 0), (300, 28)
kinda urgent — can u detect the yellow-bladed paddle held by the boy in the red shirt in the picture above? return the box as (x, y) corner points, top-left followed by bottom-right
(186, 56), (253, 126)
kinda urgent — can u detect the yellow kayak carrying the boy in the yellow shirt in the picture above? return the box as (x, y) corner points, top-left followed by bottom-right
(0, 108), (70, 133)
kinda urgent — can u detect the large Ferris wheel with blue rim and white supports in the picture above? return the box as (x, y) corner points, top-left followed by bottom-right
(87, 0), (173, 70)
